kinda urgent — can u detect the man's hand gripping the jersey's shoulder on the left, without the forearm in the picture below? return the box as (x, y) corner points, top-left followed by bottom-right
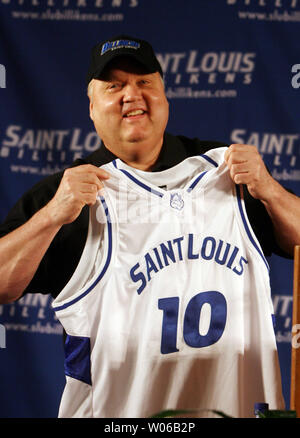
(46, 164), (109, 226)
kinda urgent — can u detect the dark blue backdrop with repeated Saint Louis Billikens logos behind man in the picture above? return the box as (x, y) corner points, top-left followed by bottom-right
(0, 0), (300, 417)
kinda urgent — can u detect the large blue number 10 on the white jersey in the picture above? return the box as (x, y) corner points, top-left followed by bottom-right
(158, 291), (227, 354)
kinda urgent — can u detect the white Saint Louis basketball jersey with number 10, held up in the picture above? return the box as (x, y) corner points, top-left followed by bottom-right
(53, 148), (284, 418)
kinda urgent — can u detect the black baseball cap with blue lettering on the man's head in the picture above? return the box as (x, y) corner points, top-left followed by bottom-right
(86, 35), (163, 84)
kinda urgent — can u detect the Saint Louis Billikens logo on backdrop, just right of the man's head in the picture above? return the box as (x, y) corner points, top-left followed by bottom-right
(156, 48), (256, 99)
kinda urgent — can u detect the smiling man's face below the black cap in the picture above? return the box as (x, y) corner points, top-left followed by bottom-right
(90, 58), (169, 160)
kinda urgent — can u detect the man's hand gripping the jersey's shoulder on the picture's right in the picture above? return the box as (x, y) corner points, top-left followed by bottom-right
(225, 144), (277, 201)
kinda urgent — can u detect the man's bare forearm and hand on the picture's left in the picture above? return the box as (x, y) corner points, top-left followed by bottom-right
(0, 164), (109, 304)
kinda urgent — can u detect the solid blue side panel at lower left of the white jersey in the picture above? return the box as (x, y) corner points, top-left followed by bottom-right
(64, 335), (92, 385)
